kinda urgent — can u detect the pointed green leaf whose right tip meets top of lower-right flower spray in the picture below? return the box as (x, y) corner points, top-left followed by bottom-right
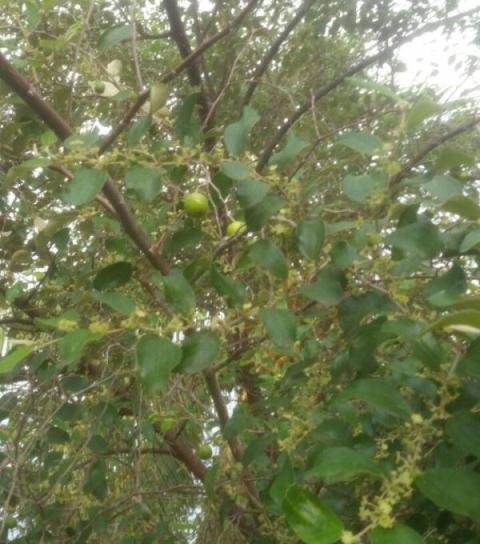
(339, 378), (412, 419)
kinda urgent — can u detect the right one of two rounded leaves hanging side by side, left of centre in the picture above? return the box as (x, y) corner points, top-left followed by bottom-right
(179, 330), (220, 374)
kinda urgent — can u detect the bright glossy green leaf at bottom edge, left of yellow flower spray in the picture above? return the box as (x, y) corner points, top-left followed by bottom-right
(282, 486), (343, 544)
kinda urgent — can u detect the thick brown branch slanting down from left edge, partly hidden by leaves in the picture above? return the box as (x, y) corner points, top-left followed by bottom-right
(0, 53), (169, 273)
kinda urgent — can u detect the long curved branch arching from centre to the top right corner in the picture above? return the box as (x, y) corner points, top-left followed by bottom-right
(257, 8), (480, 172)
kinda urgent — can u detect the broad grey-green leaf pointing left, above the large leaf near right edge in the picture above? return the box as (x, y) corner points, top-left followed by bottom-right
(386, 222), (443, 259)
